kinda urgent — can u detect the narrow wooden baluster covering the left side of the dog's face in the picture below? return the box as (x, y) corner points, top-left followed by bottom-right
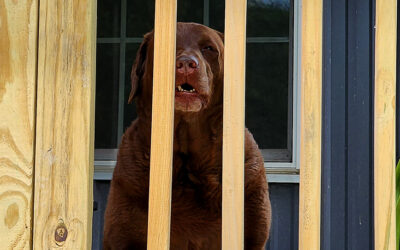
(147, 0), (177, 250)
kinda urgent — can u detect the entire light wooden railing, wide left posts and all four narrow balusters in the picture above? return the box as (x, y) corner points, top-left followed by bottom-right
(0, 0), (397, 250)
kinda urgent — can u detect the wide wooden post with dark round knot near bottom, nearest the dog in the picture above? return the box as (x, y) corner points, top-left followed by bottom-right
(33, 0), (96, 249)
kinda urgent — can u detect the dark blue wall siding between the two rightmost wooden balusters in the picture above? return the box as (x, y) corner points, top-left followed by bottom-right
(321, 0), (374, 250)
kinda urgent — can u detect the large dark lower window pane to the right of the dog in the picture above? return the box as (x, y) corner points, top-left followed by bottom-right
(246, 43), (289, 149)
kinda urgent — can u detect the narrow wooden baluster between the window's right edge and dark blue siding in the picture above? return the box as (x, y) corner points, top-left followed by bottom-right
(299, 0), (323, 250)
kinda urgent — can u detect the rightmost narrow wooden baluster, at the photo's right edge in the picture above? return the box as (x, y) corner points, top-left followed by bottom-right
(374, 0), (397, 250)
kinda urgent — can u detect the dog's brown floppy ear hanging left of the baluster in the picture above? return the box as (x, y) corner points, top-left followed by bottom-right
(128, 32), (153, 103)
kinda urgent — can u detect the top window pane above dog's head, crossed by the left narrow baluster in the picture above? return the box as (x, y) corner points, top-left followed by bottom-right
(126, 0), (204, 37)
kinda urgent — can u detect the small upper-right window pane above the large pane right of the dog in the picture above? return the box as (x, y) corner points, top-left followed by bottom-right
(247, 0), (290, 37)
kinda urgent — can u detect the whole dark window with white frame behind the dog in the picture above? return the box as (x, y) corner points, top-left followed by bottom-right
(95, 0), (299, 180)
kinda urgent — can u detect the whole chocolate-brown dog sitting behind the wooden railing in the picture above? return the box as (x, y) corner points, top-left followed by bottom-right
(104, 23), (271, 250)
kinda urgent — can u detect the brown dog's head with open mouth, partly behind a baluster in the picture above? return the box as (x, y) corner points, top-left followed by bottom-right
(129, 23), (224, 113)
